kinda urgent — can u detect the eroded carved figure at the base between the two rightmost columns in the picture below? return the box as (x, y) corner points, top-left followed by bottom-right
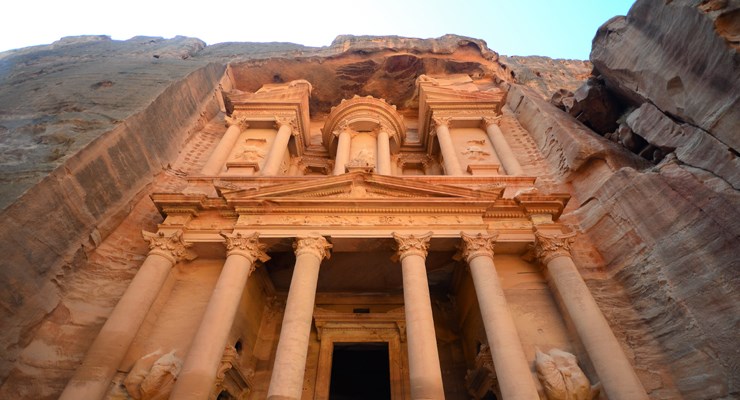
(534, 349), (601, 400)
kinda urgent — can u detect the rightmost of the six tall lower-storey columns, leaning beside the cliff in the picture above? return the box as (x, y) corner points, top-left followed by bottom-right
(535, 231), (648, 400)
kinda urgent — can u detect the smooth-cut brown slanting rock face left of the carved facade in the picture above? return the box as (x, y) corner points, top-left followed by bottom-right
(0, 49), (224, 390)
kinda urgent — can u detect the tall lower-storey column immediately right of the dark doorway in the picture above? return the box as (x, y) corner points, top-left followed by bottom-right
(393, 232), (445, 400)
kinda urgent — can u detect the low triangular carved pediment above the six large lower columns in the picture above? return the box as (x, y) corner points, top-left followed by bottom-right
(222, 172), (503, 201)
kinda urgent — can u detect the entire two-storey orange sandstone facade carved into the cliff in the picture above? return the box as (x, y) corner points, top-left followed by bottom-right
(57, 75), (647, 400)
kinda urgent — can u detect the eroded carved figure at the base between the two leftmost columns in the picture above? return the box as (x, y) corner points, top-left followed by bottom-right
(123, 350), (182, 400)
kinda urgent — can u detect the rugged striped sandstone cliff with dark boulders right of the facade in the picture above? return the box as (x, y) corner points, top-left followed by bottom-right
(507, 0), (740, 399)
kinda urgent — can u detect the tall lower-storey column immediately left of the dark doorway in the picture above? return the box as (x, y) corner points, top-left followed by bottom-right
(267, 235), (331, 400)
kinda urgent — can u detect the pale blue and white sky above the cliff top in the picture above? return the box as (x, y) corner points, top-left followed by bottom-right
(0, 0), (633, 60)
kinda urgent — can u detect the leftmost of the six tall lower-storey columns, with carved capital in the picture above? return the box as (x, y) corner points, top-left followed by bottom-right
(60, 230), (195, 400)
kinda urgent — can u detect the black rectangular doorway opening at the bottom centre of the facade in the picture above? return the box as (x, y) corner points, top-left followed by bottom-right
(329, 343), (391, 400)
